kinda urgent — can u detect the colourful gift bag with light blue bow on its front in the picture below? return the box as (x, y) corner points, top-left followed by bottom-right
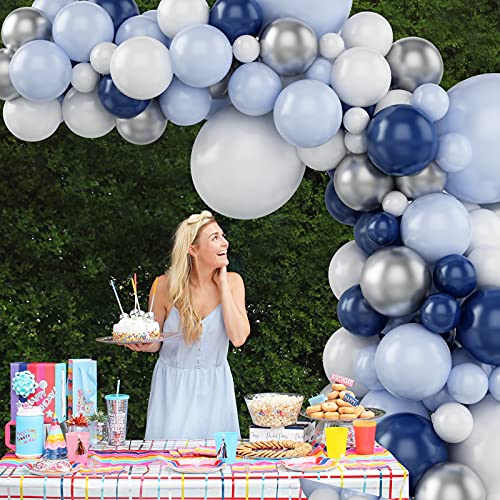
(10, 362), (66, 424)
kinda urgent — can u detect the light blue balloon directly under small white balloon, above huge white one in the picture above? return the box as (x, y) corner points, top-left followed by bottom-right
(228, 62), (282, 116)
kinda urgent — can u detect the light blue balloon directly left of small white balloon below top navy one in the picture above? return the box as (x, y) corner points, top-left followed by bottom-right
(170, 24), (233, 87)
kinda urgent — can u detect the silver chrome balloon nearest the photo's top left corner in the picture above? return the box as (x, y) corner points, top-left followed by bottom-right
(2, 7), (52, 50)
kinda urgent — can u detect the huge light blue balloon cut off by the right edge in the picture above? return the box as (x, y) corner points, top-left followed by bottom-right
(436, 73), (500, 203)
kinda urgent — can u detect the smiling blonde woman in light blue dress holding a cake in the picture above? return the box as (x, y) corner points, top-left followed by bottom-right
(131, 211), (250, 439)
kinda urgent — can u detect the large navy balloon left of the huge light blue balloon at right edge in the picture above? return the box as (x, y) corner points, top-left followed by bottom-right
(366, 104), (439, 176)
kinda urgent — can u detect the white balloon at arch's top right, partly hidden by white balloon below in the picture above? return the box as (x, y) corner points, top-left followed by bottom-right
(341, 12), (394, 56)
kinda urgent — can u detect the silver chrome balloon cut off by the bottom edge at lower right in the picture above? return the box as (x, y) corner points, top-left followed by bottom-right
(415, 462), (486, 500)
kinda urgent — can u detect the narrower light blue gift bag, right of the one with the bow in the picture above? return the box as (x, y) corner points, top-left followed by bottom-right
(68, 359), (97, 418)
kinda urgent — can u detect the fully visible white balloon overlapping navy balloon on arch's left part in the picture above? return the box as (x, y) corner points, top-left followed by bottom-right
(111, 36), (173, 100)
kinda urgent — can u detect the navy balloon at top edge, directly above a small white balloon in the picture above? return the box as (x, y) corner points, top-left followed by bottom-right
(208, 0), (263, 44)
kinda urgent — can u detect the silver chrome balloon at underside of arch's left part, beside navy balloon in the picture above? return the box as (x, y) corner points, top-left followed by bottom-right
(116, 100), (167, 146)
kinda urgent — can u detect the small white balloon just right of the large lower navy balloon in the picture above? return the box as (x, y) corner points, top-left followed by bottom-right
(431, 403), (474, 443)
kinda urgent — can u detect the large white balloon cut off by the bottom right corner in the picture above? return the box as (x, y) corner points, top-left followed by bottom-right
(450, 394), (500, 500)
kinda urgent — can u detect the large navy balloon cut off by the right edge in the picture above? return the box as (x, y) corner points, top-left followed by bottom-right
(457, 288), (500, 366)
